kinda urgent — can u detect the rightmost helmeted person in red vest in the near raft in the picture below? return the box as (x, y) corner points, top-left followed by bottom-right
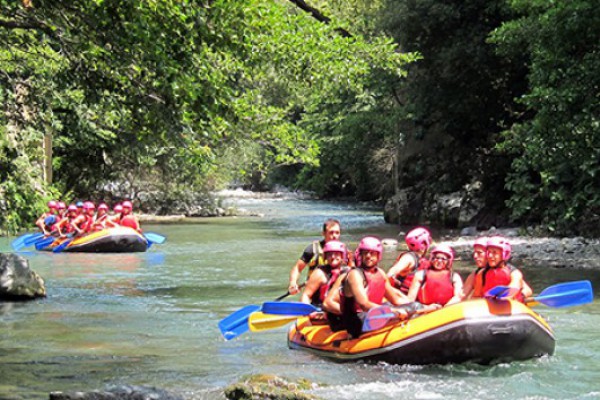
(472, 236), (533, 301)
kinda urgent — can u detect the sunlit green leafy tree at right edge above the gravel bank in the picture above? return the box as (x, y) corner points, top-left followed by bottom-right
(493, 0), (600, 233)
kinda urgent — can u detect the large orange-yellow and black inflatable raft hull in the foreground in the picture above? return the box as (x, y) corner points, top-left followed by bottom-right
(288, 299), (555, 365)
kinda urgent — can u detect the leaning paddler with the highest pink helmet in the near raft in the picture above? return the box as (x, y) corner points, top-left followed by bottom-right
(387, 227), (431, 294)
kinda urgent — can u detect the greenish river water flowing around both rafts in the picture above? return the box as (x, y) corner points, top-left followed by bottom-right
(0, 199), (600, 400)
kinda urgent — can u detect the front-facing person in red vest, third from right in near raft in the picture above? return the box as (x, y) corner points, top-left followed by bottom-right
(408, 243), (462, 308)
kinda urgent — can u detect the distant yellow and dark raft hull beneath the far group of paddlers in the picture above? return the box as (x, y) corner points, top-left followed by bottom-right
(38, 227), (148, 253)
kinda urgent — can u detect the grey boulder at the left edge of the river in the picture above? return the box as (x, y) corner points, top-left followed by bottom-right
(0, 253), (46, 300)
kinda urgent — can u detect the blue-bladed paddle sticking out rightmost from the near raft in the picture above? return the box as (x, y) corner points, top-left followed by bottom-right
(486, 281), (594, 308)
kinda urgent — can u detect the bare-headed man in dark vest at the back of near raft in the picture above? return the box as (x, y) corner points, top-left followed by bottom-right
(288, 218), (354, 295)
